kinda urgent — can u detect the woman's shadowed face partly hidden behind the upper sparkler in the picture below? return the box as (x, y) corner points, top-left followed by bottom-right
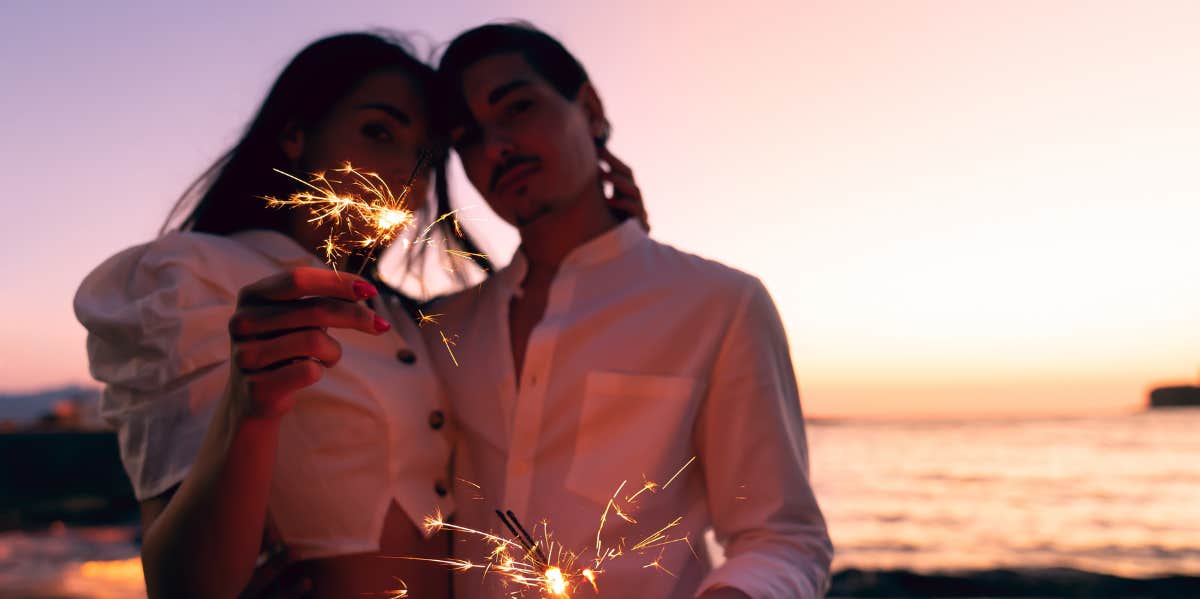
(281, 65), (431, 241)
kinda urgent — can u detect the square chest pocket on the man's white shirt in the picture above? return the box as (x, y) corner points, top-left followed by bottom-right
(564, 371), (703, 504)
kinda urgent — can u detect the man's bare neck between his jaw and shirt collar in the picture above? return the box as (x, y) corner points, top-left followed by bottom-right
(518, 187), (619, 274)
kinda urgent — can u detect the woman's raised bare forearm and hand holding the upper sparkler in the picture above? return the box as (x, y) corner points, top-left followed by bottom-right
(142, 268), (390, 599)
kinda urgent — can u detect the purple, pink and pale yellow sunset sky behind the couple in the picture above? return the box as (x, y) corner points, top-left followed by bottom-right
(0, 0), (1200, 417)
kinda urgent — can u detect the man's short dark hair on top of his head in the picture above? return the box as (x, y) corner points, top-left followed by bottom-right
(438, 22), (588, 131)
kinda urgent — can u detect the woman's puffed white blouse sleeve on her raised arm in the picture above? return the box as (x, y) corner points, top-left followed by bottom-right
(74, 234), (239, 501)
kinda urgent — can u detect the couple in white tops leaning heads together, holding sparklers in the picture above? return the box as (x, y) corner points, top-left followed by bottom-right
(76, 24), (832, 599)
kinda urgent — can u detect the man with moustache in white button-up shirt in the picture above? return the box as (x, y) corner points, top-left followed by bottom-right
(425, 25), (833, 599)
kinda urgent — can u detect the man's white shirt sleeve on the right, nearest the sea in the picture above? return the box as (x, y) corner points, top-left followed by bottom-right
(695, 280), (833, 599)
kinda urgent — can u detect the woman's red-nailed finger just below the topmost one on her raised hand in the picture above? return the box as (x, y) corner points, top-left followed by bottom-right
(229, 298), (391, 340)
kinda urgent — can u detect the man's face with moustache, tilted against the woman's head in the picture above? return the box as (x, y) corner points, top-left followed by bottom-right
(451, 53), (602, 227)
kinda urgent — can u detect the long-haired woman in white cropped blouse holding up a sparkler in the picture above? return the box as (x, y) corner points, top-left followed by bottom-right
(76, 34), (474, 598)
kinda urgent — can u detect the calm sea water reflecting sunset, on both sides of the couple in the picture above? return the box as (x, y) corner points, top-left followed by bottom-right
(0, 409), (1200, 599)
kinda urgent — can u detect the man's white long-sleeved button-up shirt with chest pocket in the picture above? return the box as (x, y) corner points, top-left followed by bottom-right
(422, 220), (833, 599)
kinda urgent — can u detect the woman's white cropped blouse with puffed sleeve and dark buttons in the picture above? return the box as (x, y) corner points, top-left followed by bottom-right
(74, 230), (454, 559)
